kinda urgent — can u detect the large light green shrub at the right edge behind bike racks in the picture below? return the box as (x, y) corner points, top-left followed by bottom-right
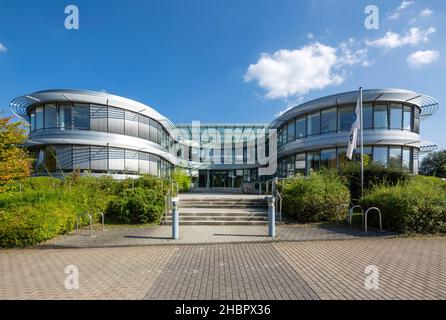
(360, 176), (446, 234)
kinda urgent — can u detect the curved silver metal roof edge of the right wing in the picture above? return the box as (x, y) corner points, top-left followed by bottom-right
(270, 89), (439, 128)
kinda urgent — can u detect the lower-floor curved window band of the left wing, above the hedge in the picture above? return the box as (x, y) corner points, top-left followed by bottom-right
(32, 145), (173, 178)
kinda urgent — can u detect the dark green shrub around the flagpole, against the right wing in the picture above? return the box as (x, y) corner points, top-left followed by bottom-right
(339, 162), (409, 203)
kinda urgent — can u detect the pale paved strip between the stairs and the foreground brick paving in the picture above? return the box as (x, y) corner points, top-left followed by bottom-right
(37, 225), (394, 248)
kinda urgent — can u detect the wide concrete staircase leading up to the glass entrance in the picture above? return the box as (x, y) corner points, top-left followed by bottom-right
(166, 194), (268, 225)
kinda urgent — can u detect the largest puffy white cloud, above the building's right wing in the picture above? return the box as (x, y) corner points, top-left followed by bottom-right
(245, 39), (367, 99)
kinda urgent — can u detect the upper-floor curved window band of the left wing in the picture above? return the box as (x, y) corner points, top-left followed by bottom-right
(28, 102), (172, 149)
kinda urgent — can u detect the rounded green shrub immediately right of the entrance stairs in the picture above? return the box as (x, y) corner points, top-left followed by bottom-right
(282, 171), (350, 223)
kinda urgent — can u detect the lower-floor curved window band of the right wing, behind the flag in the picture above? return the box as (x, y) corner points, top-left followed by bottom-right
(277, 146), (418, 178)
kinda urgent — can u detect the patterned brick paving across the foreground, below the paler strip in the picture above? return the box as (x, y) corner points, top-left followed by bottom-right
(0, 237), (446, 299)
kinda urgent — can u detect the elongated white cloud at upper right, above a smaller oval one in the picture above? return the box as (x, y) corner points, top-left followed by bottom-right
(366, 28), (435, 49)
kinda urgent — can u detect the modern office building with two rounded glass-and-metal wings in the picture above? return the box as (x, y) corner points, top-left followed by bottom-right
(10, 89), (438, 188)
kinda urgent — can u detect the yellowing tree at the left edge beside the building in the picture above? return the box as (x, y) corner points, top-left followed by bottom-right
(0, 117), (31, 190)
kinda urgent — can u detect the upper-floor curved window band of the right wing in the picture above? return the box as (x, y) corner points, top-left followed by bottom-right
(278, 102), (420, 147)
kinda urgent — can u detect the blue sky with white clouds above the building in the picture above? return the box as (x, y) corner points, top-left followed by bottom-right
(0, 0), (446, 149)
